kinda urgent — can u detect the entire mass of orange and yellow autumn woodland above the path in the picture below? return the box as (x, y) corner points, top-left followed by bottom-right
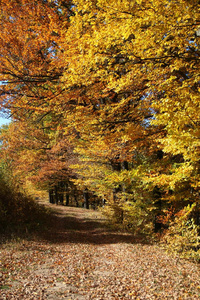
(0, 0), (200, 260)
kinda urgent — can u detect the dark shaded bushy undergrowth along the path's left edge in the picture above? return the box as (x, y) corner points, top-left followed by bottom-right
(0, 173), (51, 242)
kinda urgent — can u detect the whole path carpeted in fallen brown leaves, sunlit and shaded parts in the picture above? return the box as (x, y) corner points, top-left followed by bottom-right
(0, 203), (200, 300)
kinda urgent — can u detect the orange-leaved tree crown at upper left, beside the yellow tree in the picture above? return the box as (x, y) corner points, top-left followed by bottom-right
(0, 0), (70, 119)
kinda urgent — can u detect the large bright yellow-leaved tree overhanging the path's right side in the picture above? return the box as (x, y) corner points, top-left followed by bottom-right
(59, 1), (199, 230)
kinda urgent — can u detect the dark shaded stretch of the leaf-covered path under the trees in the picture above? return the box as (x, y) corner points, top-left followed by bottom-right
(38, 206), (146, 245)
